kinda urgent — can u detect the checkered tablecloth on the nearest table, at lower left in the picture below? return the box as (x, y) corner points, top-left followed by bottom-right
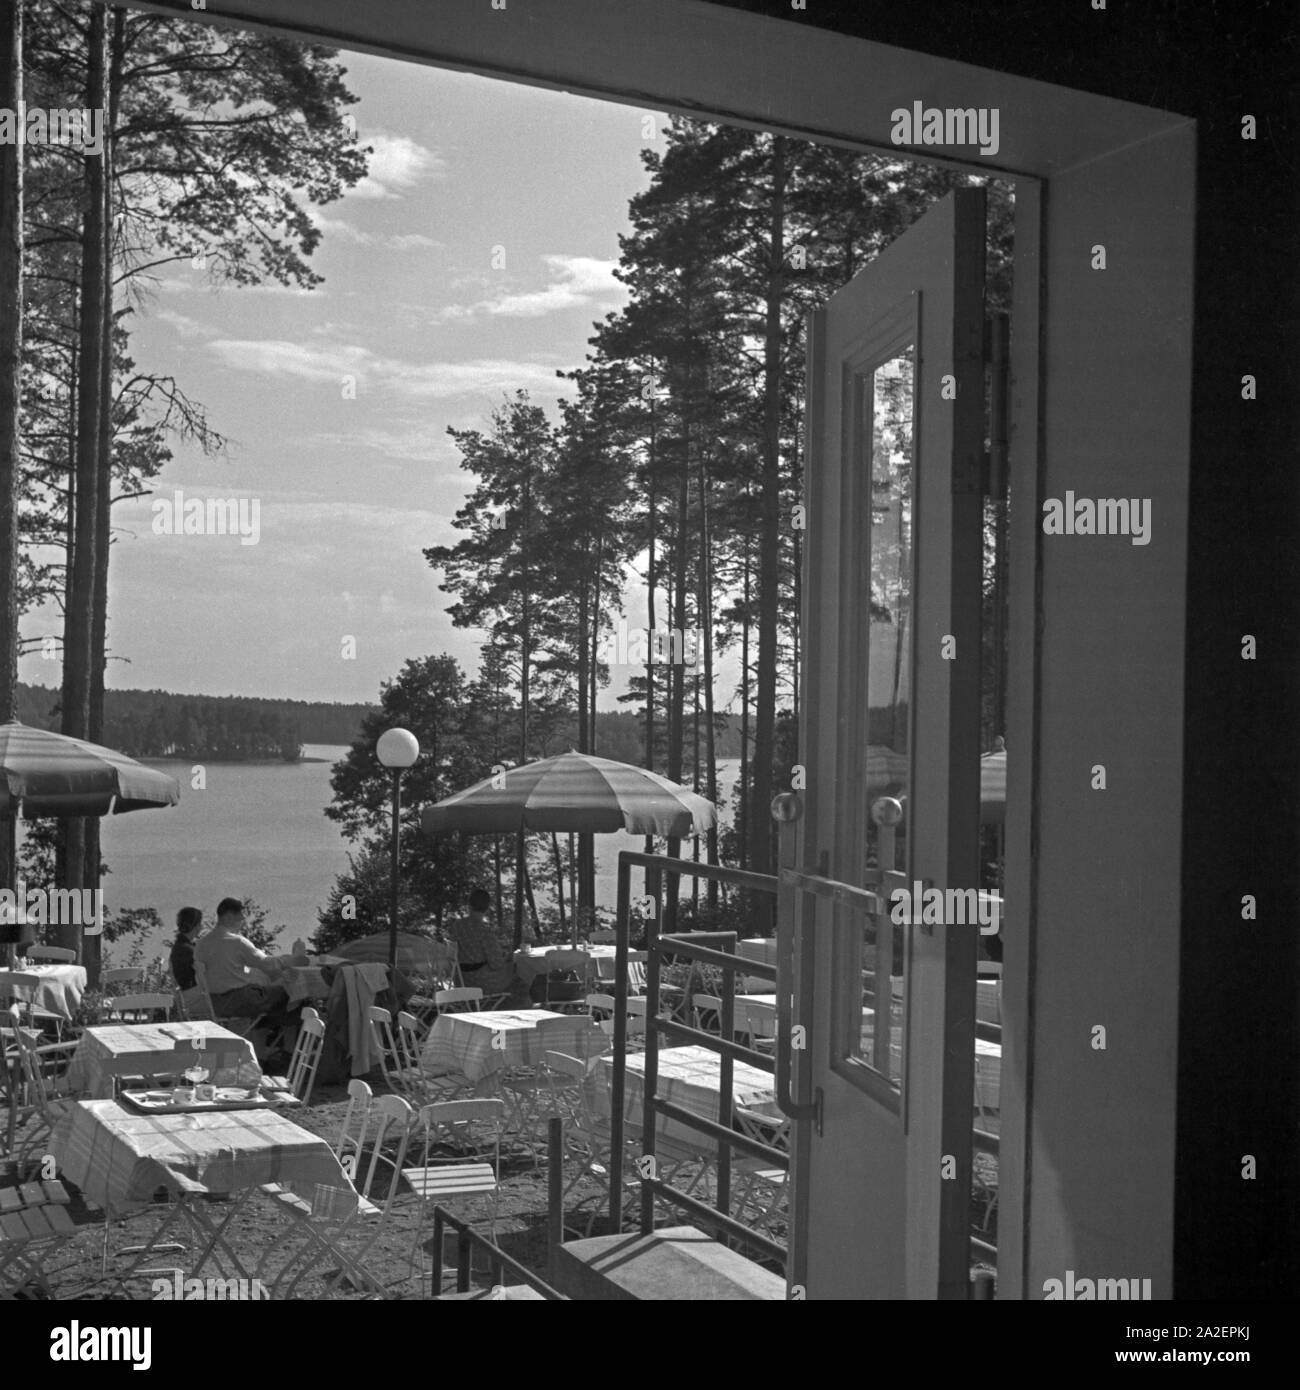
(50, 1101), (352, 1213)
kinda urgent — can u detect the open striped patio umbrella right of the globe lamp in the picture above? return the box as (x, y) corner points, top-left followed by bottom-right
(420, 753), (717, 840)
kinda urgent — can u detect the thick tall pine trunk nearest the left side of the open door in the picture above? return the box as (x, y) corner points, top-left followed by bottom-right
(749, 135), (786, 934)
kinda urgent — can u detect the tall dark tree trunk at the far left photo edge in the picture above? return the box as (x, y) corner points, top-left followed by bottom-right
(0, 0), (22, 906)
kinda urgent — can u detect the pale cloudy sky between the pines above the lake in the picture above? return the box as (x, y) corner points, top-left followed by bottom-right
(19, 54), (666, 708)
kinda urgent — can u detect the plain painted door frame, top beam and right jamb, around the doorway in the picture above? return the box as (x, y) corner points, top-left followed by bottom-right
(129, 0), (1196, 1298)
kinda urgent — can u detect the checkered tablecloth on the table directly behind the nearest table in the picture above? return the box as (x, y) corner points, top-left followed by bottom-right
(68, 1022), (261, 1098)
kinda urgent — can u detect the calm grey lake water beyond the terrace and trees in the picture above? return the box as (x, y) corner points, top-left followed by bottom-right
(45, 744), (740, 958)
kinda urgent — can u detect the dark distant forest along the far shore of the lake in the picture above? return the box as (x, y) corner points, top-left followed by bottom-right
(18, 681), (740, 766)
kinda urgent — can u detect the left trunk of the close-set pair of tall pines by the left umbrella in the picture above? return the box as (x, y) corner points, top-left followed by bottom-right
(57, 3), (108, 954)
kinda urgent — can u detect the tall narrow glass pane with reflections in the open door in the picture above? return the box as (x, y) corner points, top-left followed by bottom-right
(858, 348), (915, 1086)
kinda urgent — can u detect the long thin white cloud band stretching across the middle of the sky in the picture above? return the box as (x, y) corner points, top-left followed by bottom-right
(207, 338), (563, 400)
